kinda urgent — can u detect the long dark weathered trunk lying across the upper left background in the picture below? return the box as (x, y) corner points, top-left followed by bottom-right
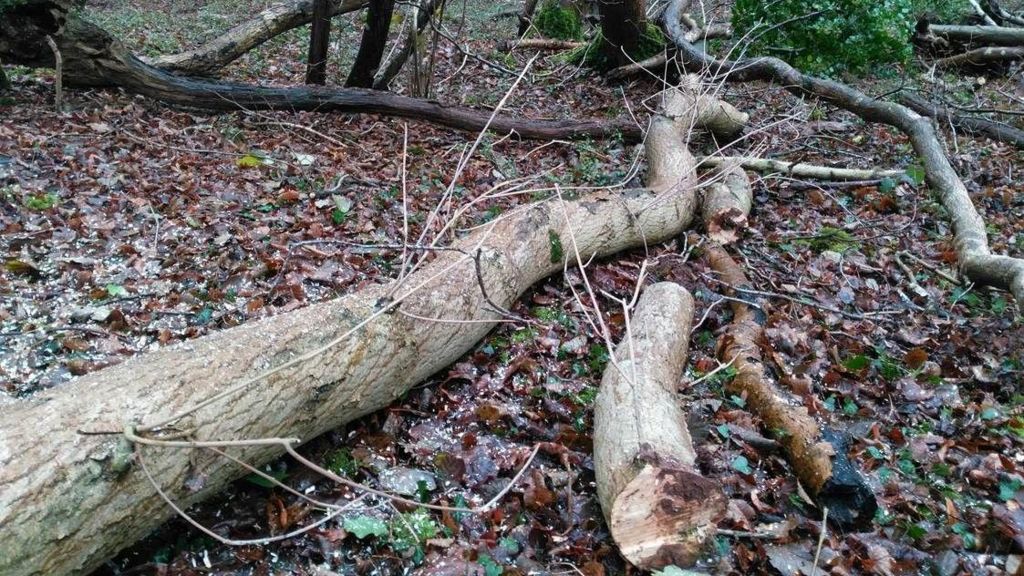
(0, 8), (641, 142)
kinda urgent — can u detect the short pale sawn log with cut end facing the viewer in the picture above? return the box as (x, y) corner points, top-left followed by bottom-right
(594, 280), (727, 570)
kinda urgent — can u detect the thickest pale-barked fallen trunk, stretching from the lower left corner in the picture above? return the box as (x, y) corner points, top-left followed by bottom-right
(0, 65), (695, 576)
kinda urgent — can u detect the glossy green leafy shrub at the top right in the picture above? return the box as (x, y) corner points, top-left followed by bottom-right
(732, 0), (966, 75)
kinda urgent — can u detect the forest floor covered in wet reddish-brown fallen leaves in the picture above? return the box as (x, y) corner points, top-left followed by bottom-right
(0, 0), (1024, 576)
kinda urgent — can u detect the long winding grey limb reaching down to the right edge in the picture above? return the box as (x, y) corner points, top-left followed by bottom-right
(664, 0), (1024, 310)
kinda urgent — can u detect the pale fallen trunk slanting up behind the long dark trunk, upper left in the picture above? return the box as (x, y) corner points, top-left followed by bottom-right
(144, 0), (366, 76)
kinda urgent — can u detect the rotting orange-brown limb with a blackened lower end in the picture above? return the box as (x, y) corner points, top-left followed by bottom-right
(705, 244), (878, 526)
